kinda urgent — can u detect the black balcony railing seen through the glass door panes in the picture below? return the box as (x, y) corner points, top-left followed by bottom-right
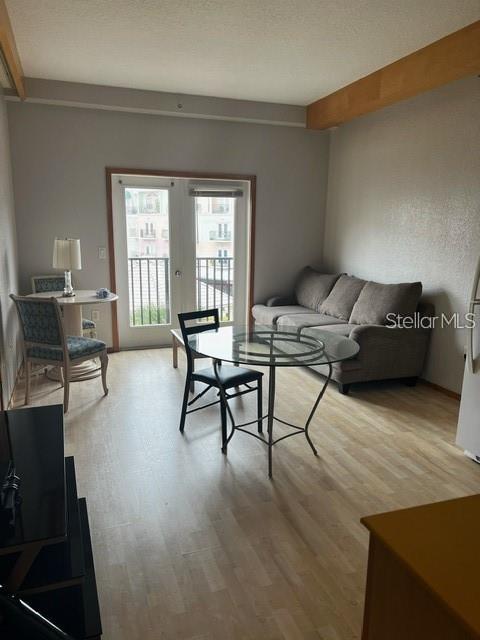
(128, 257), (234, 326)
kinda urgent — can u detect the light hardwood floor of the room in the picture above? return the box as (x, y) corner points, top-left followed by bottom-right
(12, 349), (480, 640)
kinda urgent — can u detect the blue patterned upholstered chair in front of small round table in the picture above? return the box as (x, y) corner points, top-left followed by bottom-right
(10, 294), (108, 413)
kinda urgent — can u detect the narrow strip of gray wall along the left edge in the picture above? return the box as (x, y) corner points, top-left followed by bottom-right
(0, 87), (19, 406)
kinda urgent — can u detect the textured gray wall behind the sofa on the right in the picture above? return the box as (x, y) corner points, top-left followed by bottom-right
(324, 77), (480, 391)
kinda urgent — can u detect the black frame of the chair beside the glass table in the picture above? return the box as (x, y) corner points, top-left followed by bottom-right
(178, 309), (263, 451)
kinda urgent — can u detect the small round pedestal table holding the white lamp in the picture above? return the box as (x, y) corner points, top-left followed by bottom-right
(29, 289), (118, 382)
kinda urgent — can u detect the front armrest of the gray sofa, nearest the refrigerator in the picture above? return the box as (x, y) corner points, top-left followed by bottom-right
(344, 324), (430, 380)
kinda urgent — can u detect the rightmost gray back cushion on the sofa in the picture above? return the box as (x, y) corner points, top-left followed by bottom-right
(350, 282), (422, 324)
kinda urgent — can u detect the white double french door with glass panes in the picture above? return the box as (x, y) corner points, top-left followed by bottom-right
(111, 174), (251, 349)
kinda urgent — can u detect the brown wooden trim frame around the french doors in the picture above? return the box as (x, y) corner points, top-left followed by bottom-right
(105, 167), (257, 352)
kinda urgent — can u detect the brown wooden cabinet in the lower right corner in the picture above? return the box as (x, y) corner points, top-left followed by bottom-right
(362, 496), (480, 640)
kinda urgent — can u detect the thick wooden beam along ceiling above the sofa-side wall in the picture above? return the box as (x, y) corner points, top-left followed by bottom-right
(307, 20), (480, 129)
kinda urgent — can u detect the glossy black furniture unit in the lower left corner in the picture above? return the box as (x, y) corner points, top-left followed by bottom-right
(0, 405), (102, 640)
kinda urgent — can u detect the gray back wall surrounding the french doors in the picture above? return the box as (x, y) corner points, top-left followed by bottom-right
(8, 102), (328, 341)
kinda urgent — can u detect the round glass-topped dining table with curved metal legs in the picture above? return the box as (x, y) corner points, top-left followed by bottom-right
(188, 325), (360, 478)
